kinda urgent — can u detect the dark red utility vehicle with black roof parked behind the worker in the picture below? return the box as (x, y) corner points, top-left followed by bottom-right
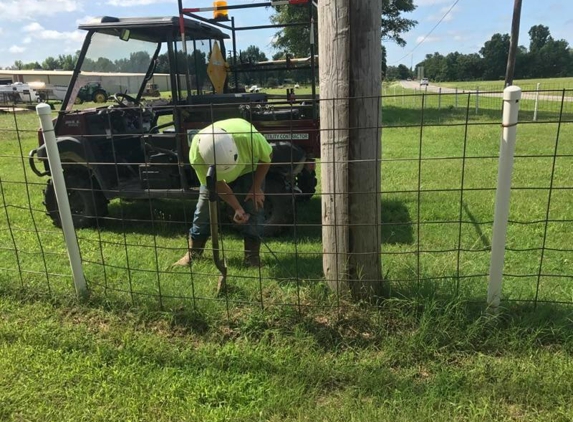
(29, 0), (320, 236)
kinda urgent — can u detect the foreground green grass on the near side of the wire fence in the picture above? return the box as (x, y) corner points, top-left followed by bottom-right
(0, 296), (573, 421)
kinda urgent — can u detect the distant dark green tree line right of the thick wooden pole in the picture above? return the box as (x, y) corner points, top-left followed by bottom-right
(385, 25), (573, 82)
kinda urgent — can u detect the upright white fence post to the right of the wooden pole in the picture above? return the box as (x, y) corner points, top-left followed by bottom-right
(487, 86), (521, 311)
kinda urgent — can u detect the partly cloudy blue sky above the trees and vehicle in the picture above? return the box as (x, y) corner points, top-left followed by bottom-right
(0, 0), (573, 67)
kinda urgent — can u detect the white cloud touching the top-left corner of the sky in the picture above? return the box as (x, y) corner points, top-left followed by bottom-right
(0, 0), (81, 21)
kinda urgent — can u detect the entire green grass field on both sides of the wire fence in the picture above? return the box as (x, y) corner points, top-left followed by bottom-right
(0, 87), (573, 421)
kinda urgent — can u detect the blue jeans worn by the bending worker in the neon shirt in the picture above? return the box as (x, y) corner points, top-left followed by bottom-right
(189, 173), (265, 239)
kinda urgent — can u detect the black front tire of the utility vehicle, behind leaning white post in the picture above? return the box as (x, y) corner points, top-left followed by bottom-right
(44, 174), (108, 229)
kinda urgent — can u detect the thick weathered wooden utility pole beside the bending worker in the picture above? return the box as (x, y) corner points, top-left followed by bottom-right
(318, 0), (382, 299)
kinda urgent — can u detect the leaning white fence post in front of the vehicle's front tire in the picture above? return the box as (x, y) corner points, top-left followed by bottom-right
(36, 103), (88, 299)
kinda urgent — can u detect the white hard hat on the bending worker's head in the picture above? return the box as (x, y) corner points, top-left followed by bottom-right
(197, 126), (239, 175)
